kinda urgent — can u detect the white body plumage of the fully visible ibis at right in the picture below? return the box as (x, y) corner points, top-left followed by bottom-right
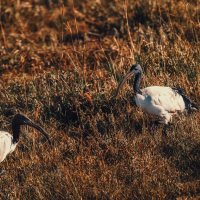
(135, 86), (185, 124)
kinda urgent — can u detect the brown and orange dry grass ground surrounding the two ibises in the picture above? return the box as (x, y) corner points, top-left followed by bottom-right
(0, 0), (200, 200)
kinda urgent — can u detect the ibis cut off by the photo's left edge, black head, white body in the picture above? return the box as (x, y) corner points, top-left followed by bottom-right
(0, 114), (51, 163)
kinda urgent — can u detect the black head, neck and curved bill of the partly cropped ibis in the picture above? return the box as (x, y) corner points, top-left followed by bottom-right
(12, 114), (51, 144)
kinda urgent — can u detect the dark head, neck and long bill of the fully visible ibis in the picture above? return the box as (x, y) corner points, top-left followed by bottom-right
(116, 64), (142, 97)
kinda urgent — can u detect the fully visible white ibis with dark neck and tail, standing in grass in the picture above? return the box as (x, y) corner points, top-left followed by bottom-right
(116, 64), (198, 136)
